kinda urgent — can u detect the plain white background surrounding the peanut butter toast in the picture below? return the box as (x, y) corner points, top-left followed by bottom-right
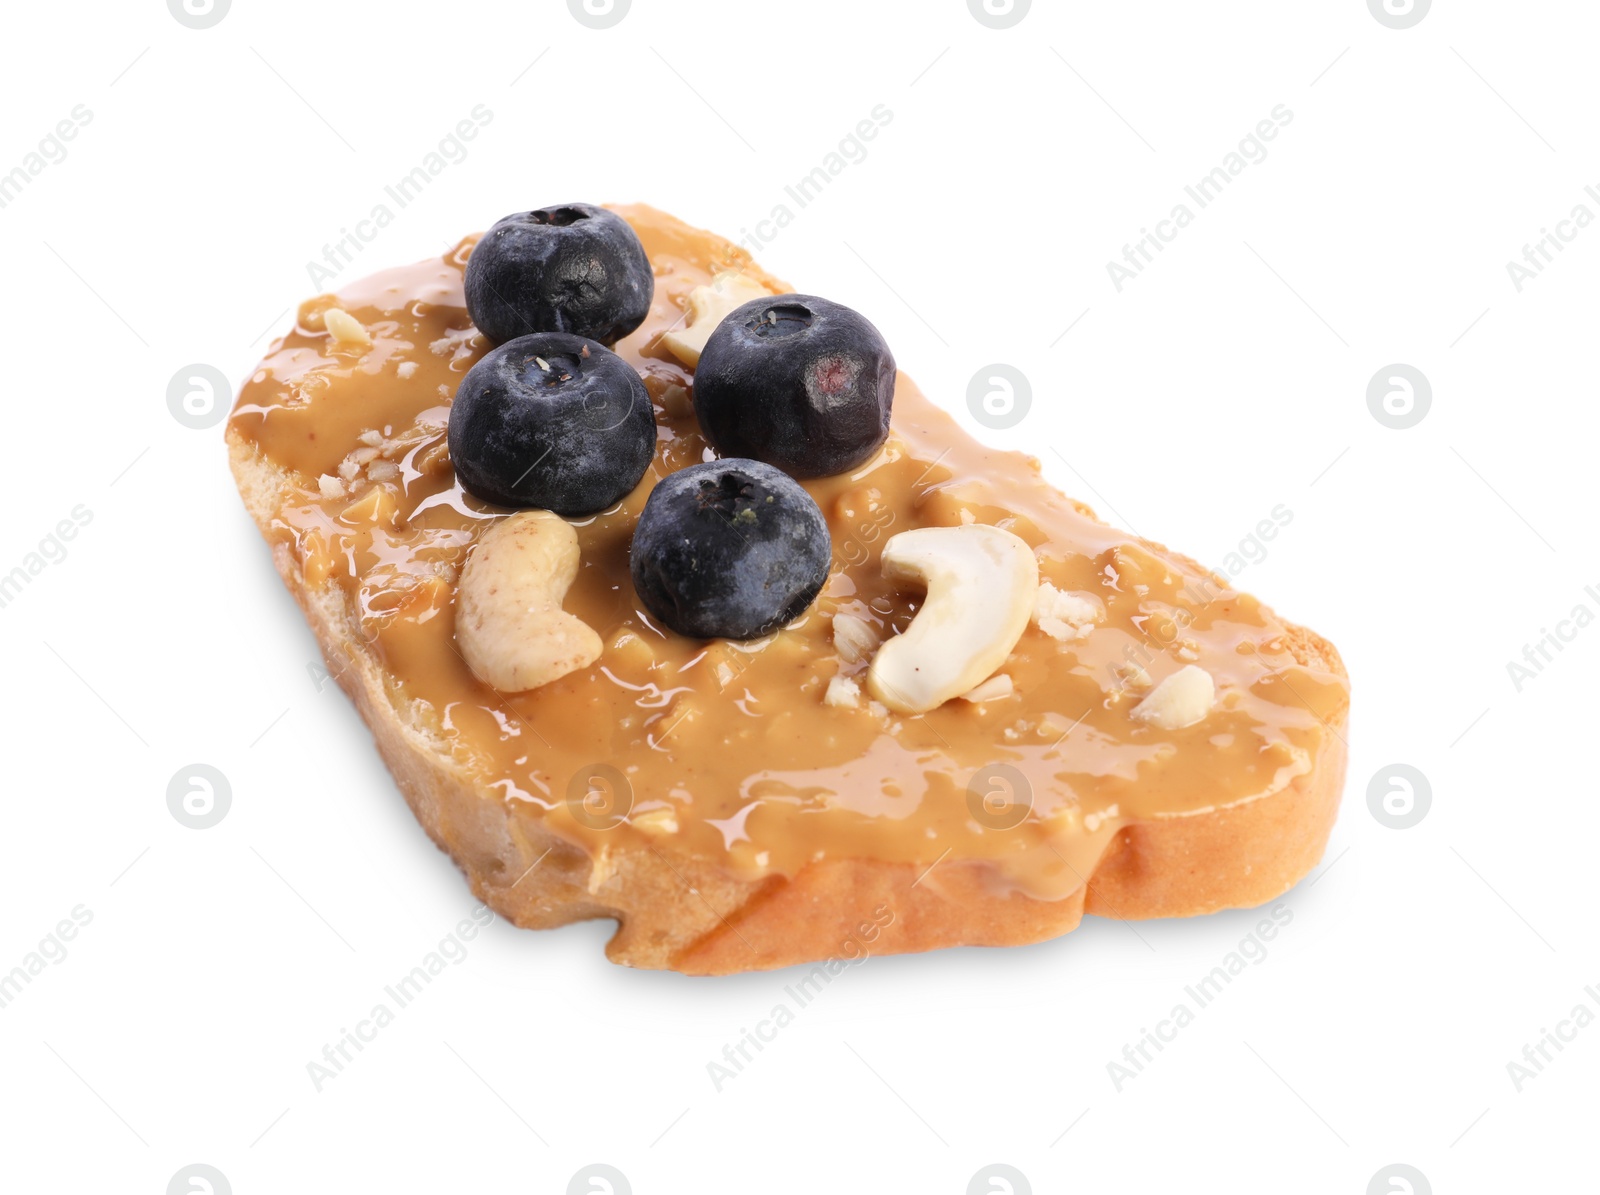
(0, 0), (1600, 1195)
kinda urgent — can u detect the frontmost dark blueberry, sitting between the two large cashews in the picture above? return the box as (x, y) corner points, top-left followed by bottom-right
(630, 459), (832, 638)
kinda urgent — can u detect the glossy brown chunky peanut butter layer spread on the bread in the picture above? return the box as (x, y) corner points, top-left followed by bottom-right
(232, 208), (1347, 897)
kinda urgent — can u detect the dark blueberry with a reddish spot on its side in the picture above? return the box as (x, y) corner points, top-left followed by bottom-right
(694, 294), (894, 477)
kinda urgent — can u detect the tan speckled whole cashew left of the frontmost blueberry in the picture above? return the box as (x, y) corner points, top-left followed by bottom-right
(456, 510), (600, 693)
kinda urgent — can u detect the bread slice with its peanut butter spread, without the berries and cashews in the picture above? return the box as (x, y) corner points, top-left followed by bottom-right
(227, 206), (1347, 974)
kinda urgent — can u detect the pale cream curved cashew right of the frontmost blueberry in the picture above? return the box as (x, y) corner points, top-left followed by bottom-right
(867, 523), (1038, 713)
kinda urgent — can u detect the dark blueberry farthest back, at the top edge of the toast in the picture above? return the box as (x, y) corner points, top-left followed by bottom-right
(466, 203), (656, 344)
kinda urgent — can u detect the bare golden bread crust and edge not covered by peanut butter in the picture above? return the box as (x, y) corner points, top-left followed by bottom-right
(227, 210), (1346, 974)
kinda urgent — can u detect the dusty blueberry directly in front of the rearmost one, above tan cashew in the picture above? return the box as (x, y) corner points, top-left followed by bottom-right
(450, 333), (656, 515)
